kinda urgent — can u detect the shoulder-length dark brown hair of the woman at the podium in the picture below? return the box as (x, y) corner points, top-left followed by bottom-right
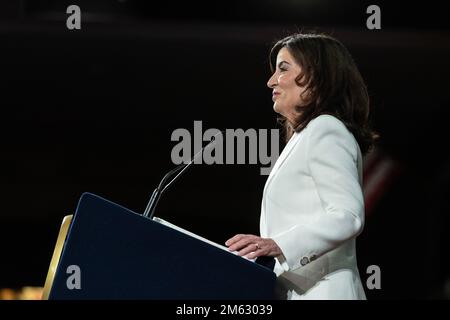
(269, 33), (378, 154)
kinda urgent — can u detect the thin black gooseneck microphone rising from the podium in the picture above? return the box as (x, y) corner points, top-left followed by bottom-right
(142, 131), (222, 219)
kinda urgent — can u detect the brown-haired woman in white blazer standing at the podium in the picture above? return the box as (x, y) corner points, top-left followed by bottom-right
(226, 34), (377, 300)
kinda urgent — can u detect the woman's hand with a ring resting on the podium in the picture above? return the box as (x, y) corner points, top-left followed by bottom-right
(225, 234), (283, 259)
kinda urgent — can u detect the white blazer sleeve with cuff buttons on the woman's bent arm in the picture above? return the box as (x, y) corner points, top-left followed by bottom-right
(273, 116), (364, 271)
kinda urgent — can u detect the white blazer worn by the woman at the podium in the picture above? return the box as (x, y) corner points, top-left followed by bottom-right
(260, 115), (366, 300)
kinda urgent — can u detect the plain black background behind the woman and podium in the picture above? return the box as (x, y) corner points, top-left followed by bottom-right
(0, 0), (450, 299)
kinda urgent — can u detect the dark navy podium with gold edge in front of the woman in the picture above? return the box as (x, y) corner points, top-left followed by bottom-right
(44, 193), (276, 300)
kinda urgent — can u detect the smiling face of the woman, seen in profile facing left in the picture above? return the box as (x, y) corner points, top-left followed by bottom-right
(267, 47), (305, 120)
